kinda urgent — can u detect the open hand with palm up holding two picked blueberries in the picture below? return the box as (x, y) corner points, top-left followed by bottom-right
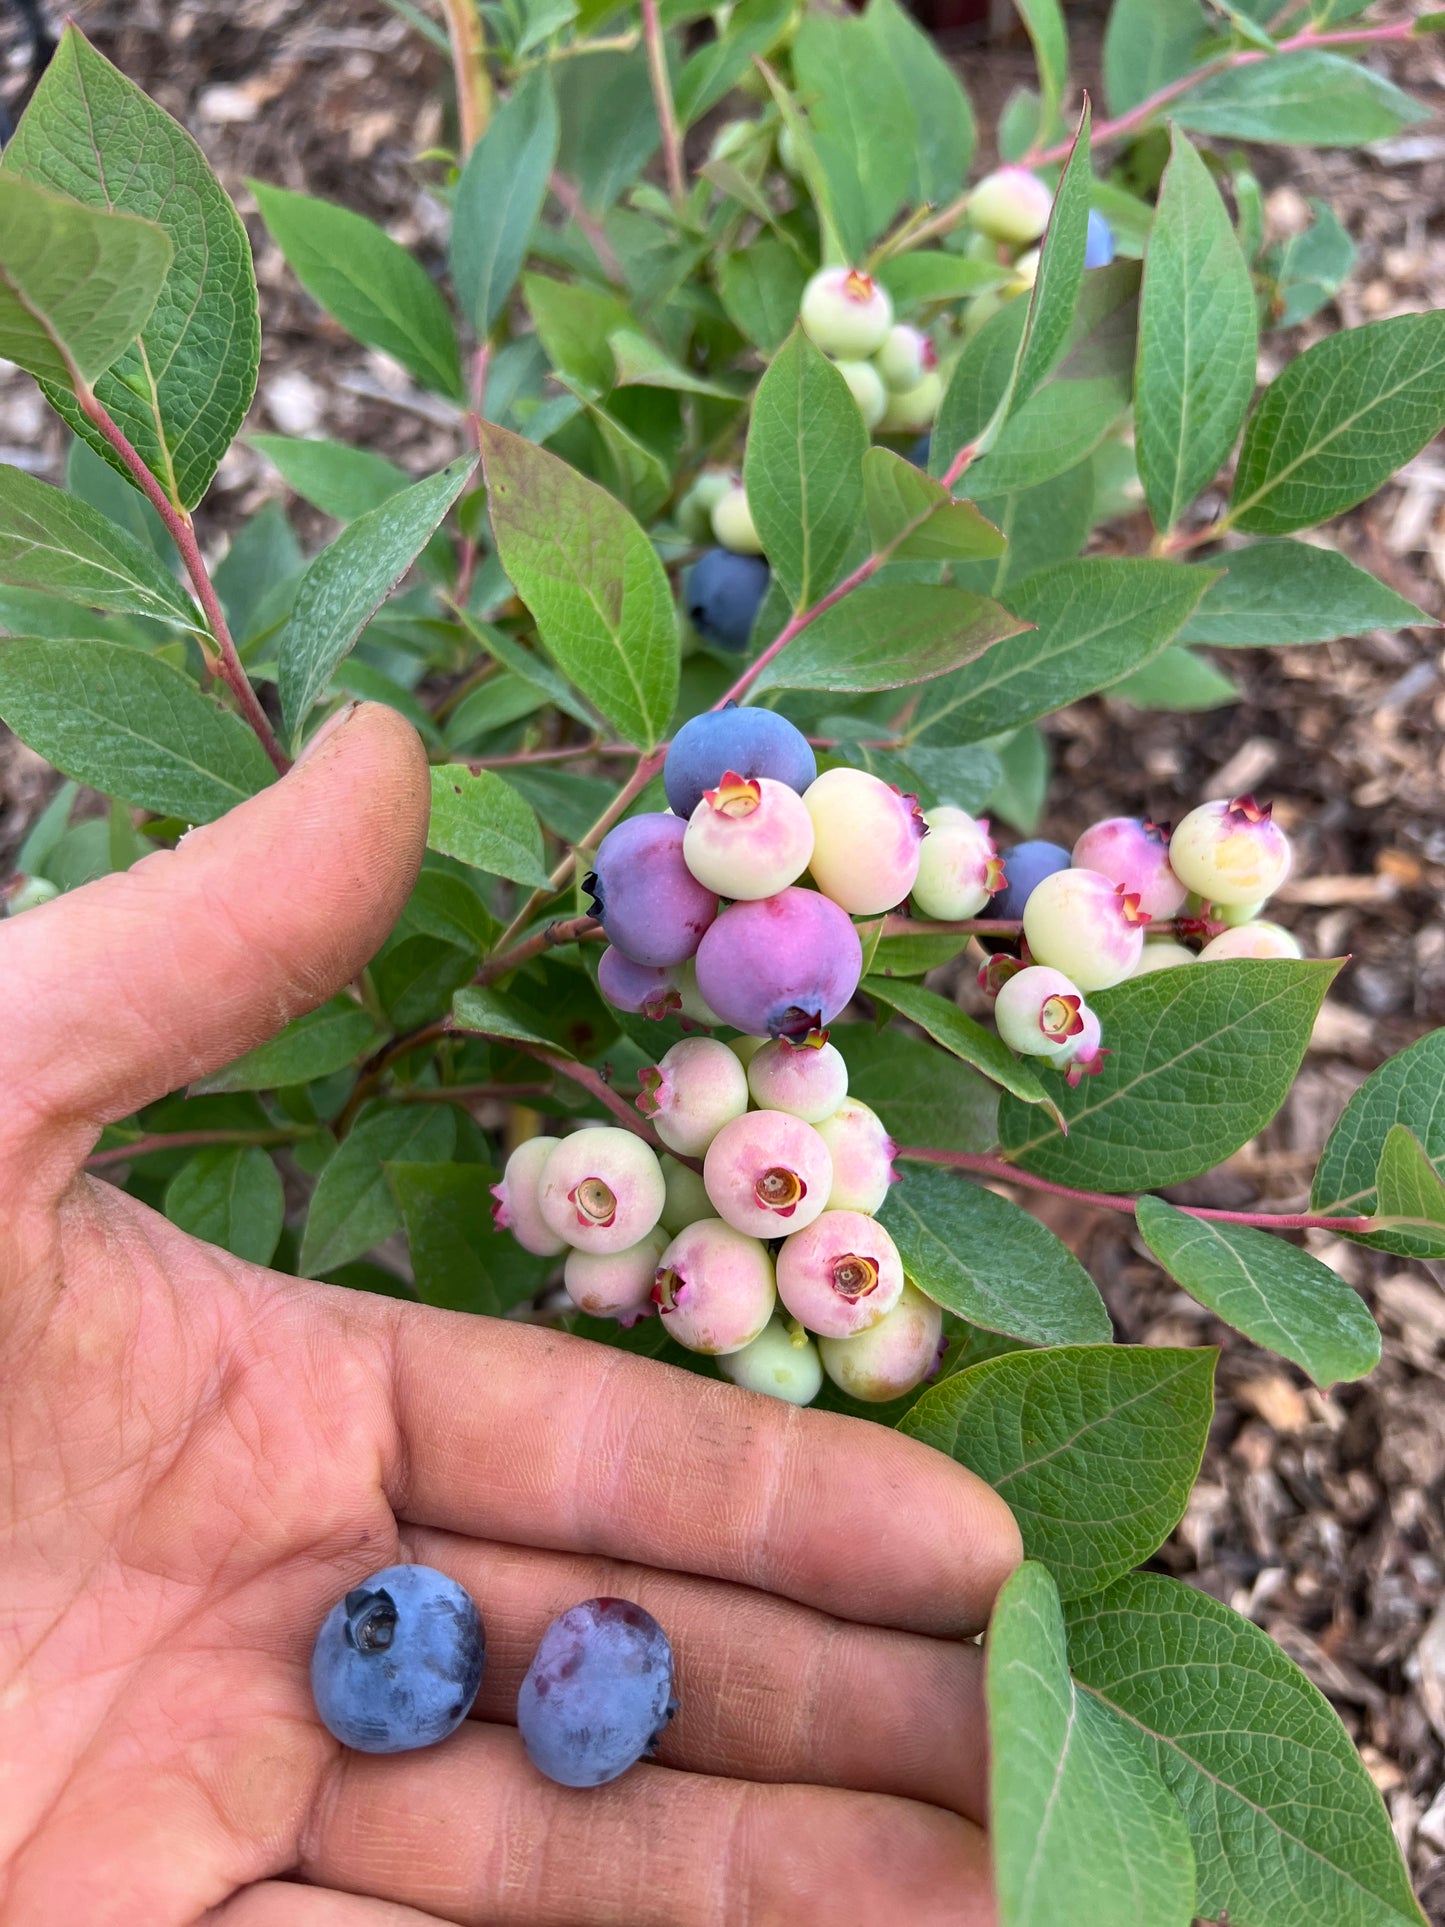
(0, 707), (1017, 1927)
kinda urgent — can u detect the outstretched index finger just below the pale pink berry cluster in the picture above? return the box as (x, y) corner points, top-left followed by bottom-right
(387, 1307), (1023, 1634)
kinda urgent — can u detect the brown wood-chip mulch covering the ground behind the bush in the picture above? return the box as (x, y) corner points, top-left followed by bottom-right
(0, 0), (1445, 1896)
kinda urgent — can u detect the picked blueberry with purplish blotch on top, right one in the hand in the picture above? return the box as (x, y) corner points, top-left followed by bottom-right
(516, 1599), (678, 1786)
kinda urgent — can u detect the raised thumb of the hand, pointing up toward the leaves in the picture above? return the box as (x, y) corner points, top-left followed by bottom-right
(0, 703), (430, 1168)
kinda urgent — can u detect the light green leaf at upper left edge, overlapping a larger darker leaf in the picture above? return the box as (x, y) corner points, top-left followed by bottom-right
(0, 173), (171, 389)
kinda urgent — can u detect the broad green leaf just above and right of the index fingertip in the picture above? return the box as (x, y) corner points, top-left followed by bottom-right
(900, 1341), (1218, 1599)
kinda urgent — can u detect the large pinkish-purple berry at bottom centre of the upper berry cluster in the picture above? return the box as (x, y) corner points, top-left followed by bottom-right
(697, 884), (863, 1043)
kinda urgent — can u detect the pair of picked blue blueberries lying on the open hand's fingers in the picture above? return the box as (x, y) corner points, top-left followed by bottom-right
(310, 1565), (678, 1786)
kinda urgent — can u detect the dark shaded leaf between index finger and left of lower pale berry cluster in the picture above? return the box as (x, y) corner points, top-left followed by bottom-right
(385, 1156), (555, 1318)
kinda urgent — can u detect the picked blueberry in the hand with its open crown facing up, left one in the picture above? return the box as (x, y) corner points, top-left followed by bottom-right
(310, 1565), (486, 1754)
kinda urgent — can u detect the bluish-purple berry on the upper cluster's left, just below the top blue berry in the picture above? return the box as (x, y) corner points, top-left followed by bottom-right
(582, 811), (717, 967)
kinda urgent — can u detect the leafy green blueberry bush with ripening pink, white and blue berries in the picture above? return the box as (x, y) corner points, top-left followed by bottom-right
(0, 0), (1445, 1927)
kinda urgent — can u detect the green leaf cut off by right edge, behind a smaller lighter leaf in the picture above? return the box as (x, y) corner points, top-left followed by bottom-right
(1310, 1031), (1445, 1258)
